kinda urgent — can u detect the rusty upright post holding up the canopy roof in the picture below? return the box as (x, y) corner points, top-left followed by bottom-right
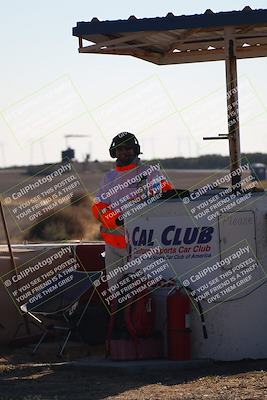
(224, 27), (241, 187)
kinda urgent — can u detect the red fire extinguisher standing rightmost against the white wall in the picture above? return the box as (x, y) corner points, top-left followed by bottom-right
(167, 288), (191, 360)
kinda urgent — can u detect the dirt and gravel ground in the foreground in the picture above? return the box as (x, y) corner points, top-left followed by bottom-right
(0, 344), (267, 400)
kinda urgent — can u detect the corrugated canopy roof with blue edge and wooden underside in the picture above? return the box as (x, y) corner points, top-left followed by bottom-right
(73, 6), (267, 64)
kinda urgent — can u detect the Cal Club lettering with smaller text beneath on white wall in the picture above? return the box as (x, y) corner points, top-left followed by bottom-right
(130, 225), (214, 259)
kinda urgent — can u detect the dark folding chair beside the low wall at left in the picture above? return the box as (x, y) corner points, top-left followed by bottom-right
(21, 271), (101, 356)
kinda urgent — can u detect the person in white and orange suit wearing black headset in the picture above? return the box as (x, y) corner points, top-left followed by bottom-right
(92, 132), (173, 286)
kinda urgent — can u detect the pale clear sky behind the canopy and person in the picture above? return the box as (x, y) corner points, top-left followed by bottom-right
(0, 0), (267, 167)
